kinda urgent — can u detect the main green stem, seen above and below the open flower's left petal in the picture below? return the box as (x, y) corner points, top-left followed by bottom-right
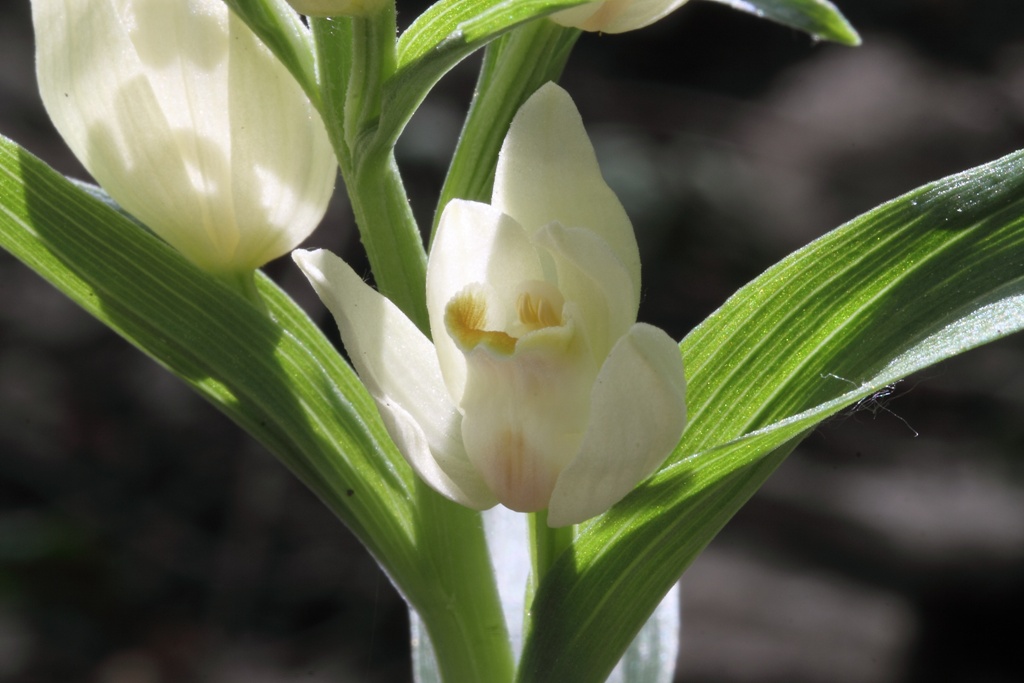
(312, 17), (514, 683)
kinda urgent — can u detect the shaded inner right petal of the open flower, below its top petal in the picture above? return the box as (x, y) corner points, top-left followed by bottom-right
(536, 223), (640, 362)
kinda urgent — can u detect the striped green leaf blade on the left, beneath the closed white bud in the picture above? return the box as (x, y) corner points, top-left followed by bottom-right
(0, 133), (415, 581)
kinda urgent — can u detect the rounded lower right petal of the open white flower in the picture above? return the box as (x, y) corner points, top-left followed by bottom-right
(548, 323), (686, 526)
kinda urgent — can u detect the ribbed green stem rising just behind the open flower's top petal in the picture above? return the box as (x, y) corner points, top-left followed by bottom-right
(433, 19), (580, 242)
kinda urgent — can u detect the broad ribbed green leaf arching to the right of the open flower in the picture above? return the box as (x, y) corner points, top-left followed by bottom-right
(520, 153), (1024, 683)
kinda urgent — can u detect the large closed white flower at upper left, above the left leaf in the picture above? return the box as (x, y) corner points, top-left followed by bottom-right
(32, 0), (337, 273)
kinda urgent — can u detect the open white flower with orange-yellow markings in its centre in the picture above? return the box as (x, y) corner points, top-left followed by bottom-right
(293, 84), (686, 526)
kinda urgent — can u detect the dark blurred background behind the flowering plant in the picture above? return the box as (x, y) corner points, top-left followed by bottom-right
(0, 0), (1024, 683)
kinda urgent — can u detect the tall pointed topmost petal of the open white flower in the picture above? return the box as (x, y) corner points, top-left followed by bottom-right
(492, 83), (640, 292)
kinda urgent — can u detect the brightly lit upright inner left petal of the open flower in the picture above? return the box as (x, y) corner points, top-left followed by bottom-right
(426, 200), (544, 403)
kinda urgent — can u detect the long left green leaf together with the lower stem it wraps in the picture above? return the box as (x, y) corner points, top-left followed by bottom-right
(0, 136), (511, 682)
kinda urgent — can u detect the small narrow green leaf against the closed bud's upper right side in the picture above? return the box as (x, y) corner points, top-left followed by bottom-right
(224, 0), (322, 110)
